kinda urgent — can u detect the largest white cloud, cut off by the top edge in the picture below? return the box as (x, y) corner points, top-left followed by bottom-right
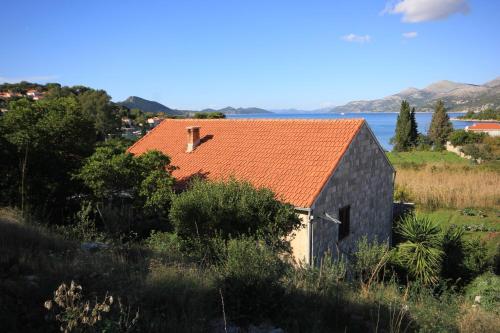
(382, 0), (470, 23)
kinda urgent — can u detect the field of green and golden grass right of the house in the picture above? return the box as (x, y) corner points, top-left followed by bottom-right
(387, 151), (500, 209)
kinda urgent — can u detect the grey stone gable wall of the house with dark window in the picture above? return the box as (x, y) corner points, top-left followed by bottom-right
(311, 124), (394, 262)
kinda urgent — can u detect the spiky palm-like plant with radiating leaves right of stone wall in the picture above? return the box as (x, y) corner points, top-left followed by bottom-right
(396, 215), (443, 285)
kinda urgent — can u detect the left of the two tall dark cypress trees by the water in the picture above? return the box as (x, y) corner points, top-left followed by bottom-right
(391, 100), (418, 151)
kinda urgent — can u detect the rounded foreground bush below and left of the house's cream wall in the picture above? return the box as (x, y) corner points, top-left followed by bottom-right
(215, 238), (287, 323)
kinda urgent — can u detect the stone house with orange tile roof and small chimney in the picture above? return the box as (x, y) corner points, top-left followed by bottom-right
(129, 119), (395, 263)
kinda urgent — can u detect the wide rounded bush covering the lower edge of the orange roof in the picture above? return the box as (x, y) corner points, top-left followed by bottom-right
(170, 179), (300, 250)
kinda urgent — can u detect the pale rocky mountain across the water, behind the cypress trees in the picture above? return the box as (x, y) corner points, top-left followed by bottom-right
(324, 77), (500, 112)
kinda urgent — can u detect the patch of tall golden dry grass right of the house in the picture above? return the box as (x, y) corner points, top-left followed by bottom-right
(396, 164), (500, 209)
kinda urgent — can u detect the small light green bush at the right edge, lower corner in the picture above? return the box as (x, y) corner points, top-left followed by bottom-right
(465, 272), (500, 315)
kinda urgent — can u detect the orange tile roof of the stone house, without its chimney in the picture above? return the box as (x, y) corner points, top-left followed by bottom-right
(129, 119), (364, 208)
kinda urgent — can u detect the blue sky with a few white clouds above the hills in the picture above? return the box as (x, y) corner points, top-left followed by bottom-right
(0, 0), (500, 109)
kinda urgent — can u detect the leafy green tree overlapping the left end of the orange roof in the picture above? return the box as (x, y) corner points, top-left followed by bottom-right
(75, 142), (174, 234)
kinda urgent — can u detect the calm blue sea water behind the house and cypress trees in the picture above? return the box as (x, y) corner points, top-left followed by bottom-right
(228, 112), (470, 150)
